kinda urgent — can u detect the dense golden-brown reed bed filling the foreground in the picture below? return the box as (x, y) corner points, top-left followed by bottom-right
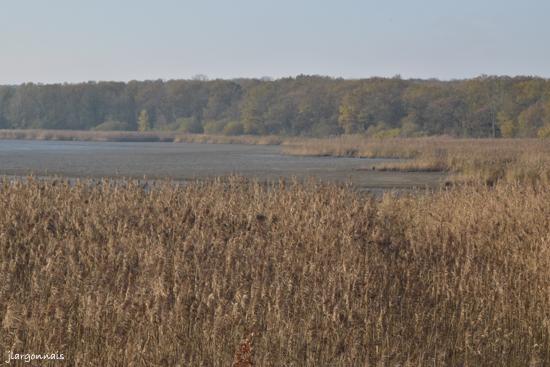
(0, 177), (550, 366)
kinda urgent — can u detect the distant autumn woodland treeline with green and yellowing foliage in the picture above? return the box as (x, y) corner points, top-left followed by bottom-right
(0, 75), (550, 137)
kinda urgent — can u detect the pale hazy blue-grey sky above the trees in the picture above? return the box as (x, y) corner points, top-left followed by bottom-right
(0, 0), (550, 84)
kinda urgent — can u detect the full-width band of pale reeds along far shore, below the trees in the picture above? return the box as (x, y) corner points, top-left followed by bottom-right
(0, 130), (550, 185)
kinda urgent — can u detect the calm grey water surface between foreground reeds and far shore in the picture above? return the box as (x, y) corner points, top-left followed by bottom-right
(0, 140), (443, 189)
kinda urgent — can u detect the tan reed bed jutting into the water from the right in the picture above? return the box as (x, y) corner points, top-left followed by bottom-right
(283, 135), (550, 185)
